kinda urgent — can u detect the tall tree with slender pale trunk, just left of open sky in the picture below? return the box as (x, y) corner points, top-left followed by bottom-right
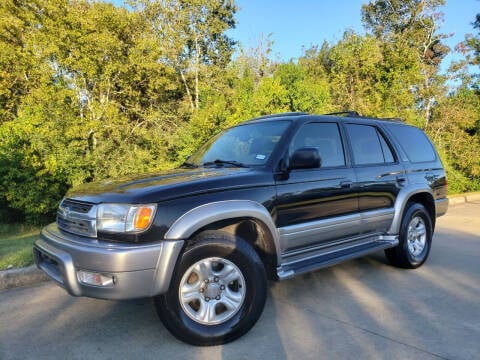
(129, 0), (236, 110)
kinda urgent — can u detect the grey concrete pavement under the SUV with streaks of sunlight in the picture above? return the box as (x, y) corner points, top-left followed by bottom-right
(0, 201), (480, 360)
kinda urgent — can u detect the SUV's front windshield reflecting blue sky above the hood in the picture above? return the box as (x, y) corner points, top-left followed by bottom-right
(187, 121), (290, 166)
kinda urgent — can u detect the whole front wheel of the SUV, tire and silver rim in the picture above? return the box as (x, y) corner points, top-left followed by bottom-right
(154, 232), (267, 346)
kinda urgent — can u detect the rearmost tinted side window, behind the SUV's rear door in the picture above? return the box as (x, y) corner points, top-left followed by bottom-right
(387, 124), (436, 162)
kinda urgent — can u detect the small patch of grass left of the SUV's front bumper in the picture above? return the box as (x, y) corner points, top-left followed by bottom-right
(0, 224), (41, 270)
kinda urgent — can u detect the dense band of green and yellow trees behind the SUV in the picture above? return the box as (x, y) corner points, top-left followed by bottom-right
(0, 0), (480, 223)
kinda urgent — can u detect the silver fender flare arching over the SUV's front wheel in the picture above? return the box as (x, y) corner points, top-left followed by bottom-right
(165, 200), (281, 260)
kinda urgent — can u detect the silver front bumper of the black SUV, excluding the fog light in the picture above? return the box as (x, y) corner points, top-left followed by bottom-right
(33, 223), (184, 299)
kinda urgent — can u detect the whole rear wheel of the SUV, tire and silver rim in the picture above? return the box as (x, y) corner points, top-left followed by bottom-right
(385, 203), (433, 269)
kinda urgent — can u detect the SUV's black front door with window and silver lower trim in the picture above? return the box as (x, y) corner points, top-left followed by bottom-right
(276, 122), (361, 251)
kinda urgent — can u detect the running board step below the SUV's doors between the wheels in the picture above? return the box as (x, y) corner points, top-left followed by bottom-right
(277, 236), (398, 280)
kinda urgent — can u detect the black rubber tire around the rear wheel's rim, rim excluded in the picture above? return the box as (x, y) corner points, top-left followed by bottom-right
(400, 203), (432, 268)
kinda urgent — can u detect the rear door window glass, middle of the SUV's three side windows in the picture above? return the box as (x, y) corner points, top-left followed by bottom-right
(346, 124), (395, 165)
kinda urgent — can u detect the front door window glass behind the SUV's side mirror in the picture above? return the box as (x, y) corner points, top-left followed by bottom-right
(289, 123), (345, 167)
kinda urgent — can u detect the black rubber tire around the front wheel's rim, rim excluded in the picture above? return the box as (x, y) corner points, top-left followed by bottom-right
(157, 237), (267, 345)
